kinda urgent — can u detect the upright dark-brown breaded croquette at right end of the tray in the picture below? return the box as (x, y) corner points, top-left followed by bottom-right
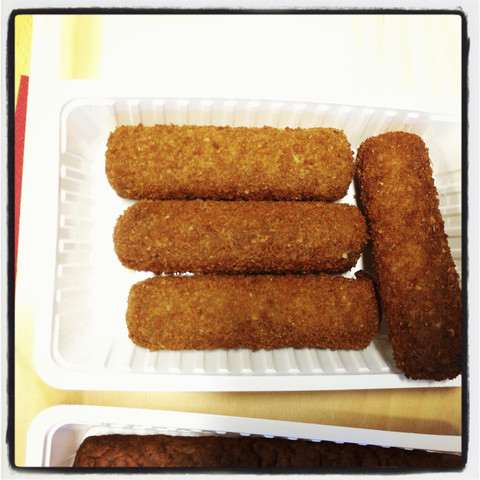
(357, 132), (461, 380)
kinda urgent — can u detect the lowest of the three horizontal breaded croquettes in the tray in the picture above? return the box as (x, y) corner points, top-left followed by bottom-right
(126, 272), (379, 351)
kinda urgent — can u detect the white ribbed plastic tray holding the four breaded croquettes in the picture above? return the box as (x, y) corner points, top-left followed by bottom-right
(34, 82), (461, 391)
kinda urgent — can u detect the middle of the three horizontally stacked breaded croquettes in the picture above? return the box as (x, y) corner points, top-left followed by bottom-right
(113, 200), (367, 274)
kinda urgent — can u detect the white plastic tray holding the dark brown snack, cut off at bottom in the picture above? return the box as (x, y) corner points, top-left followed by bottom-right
(25, 405), (461, 467)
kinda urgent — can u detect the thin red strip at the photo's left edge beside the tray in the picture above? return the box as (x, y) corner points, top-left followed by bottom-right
(15, 75), (29, 277)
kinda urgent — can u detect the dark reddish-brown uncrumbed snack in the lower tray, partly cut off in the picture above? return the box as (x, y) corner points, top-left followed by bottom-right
(73, 434), (462, 468)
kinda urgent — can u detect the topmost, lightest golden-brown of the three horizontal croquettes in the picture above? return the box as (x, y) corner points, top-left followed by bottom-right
(105, 124), (354, 201)
